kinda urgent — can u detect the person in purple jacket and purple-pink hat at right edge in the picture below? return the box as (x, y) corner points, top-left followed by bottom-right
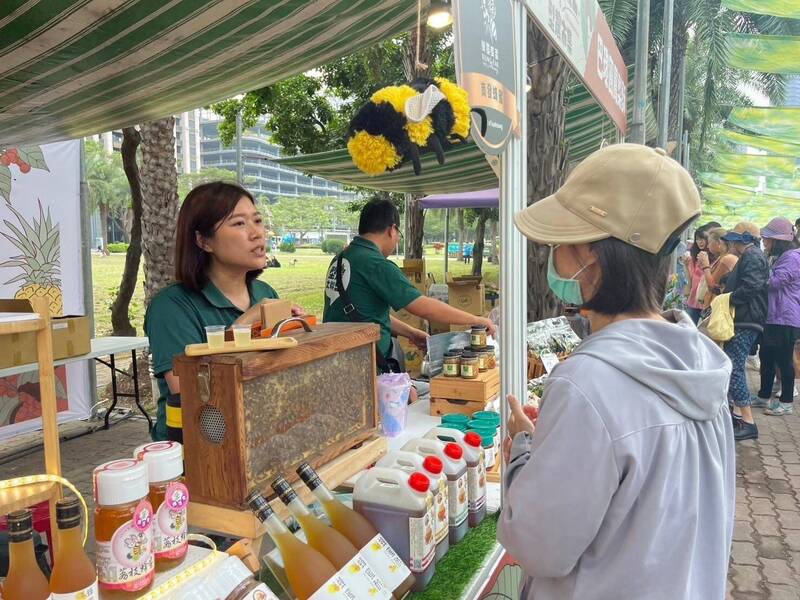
(758, 217), (800, 416)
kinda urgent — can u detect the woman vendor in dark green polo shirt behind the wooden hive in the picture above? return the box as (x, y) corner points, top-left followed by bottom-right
(144, 182), (302, 440)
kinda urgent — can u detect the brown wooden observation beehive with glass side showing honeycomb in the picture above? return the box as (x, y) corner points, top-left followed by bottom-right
(174, 323), (379, 508)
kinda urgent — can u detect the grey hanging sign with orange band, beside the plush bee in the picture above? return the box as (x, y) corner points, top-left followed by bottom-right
(453, 0), (519, 155)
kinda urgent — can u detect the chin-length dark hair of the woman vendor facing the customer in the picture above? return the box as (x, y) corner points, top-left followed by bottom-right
(175, 181), (262, 292)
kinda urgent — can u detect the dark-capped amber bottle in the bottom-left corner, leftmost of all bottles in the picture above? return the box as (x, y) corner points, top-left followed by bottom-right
(3, 509), (50, 600)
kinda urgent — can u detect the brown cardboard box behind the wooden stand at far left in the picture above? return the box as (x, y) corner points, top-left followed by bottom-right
(0, 300), (92, 369)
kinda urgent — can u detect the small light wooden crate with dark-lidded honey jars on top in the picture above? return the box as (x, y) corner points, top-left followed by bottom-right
(431, 368), (500, 417)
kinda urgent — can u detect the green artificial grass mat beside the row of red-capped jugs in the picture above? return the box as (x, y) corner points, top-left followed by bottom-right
(408, 511), (500, 600)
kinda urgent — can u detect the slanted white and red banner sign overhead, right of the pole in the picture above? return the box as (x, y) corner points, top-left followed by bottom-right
(525, 0), (628, 135)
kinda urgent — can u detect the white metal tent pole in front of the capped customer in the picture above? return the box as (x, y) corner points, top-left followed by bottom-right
(499, 0), (528, 503)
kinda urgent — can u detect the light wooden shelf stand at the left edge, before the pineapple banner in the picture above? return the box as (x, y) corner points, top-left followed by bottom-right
(0, 298), (61, 546)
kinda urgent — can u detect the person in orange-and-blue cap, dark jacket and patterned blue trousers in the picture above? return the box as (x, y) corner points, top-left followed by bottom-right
(722, 221), (769, 441)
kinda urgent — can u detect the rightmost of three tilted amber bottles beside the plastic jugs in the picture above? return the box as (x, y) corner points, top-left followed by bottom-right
(297, 463), (416, 598)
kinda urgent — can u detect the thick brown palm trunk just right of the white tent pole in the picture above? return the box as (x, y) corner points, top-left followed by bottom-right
(528, 22), (569, 321)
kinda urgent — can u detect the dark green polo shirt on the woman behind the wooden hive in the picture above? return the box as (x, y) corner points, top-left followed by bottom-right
(144, 279), (278, 440)
